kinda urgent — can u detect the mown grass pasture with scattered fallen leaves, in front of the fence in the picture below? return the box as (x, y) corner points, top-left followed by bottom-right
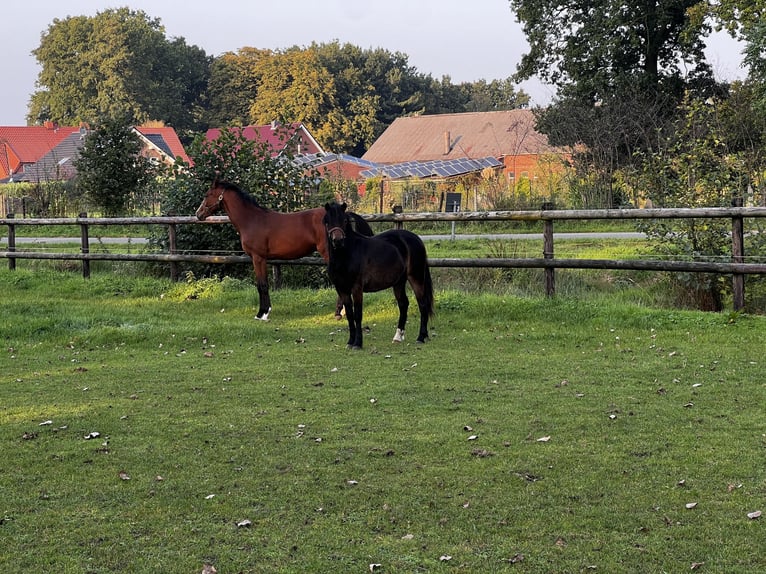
(0, 269), (766, 574)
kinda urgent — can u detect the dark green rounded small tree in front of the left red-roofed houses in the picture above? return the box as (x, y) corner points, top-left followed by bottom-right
(75, 119), (155, 217)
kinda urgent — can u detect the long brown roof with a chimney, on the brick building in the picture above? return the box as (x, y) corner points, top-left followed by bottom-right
(362, 110), (562, 164)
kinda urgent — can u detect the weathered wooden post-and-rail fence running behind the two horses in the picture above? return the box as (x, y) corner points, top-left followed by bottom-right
(0, 207), (766, 310)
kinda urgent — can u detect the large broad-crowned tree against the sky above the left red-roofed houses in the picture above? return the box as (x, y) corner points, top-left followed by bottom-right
(27, 8), (210, 130)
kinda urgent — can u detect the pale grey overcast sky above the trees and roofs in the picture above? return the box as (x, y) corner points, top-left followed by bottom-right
(0, 0), (744, 126)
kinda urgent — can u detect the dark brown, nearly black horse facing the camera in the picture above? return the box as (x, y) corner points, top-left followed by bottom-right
(323, 203), (434, 349)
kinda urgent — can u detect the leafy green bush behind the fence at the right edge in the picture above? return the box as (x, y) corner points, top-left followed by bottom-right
(637, 86), (766, 310)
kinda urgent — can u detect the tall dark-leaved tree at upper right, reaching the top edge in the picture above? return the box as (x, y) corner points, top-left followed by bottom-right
(510, 0), (720, 207)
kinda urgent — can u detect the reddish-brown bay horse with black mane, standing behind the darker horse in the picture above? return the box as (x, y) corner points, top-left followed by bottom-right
(196, 180), (373, 321)
